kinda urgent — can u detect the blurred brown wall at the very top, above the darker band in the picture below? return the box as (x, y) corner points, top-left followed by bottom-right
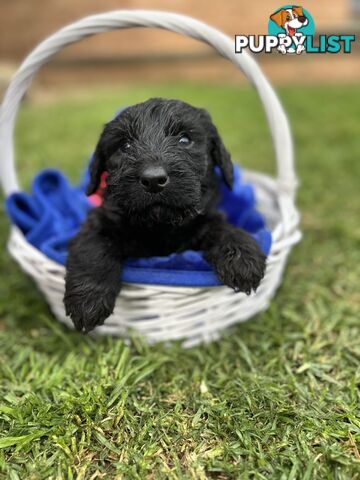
(0, 0), (350, 61)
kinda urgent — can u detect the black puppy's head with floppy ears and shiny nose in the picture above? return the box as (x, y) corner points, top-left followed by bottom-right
(88, 99), (232, 223)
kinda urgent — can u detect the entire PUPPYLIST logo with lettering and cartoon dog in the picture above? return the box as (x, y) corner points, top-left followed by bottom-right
(235, 5), (355, 55)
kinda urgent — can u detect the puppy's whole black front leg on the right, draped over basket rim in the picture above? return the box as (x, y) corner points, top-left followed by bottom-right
(201, 214), (266, 295)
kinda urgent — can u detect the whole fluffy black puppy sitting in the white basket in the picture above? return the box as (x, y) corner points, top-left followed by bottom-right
(64, 98), (265, 331)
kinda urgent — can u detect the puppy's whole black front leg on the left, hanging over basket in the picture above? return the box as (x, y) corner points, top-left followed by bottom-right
(64, 209), (122, 332)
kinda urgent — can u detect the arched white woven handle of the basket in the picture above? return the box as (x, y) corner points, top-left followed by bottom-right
(0, 10), (297, 197)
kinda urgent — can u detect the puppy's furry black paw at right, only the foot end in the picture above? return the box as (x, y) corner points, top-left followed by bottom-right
(212, 241), (266, 295)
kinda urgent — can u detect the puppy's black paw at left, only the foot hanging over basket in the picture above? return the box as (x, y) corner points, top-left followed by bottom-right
(64, 289), (117, 333)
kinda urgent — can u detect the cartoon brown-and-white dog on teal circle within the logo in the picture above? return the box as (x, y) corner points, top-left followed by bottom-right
(269, 5), (314, 55)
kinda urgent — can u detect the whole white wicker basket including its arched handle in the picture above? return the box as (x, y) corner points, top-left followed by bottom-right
(0, 10), (301, 346)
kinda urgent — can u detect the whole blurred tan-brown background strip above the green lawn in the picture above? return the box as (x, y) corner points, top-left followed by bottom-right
(0, 0), (360, 88)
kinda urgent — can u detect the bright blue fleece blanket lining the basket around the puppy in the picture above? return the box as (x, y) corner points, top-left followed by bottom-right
(6, 109), (271, 287)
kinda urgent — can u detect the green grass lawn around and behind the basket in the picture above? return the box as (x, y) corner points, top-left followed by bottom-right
(0, 85), (360, 480)
